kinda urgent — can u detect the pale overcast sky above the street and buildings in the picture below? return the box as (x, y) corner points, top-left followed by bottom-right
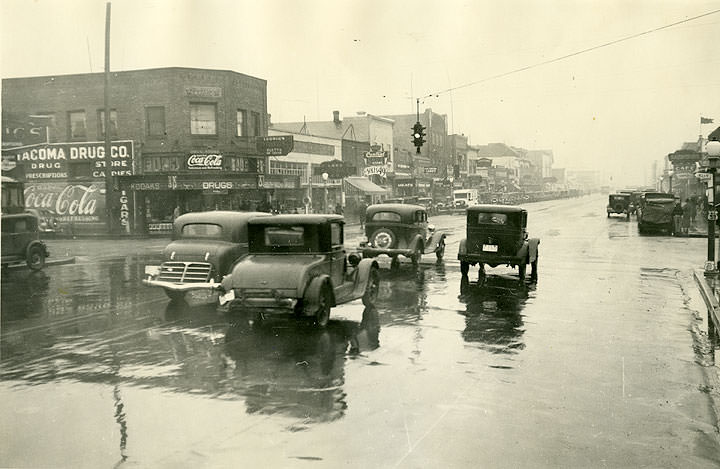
(0, 0), (720, 186)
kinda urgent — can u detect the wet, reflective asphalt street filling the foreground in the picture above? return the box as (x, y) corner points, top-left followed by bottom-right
(0, 195), (720, 468)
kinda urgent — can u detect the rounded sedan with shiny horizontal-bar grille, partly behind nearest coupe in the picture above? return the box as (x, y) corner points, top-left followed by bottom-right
(143, 210), (271, 301)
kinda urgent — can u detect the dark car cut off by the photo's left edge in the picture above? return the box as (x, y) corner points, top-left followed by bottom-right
(0, 176), (50, 270)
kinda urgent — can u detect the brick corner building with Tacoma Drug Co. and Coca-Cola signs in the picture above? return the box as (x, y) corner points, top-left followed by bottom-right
(2, 67), (270, 234)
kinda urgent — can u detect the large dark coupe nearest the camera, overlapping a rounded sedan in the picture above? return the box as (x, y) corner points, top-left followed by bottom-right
(219, 215), (379, 327)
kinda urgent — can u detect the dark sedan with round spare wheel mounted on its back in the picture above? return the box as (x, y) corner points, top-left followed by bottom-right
(360, 204), (447, 268)
